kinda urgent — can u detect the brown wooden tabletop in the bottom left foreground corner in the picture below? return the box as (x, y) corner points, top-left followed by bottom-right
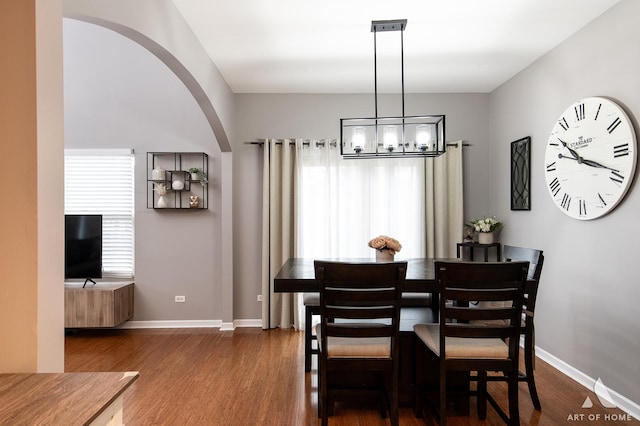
(0, 371), (138, 426)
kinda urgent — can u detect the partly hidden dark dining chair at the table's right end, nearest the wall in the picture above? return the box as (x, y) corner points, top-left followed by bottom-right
(503, 245), (544, 410)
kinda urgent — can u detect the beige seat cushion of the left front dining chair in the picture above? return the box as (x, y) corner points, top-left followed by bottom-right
(314, 324), (391, 359)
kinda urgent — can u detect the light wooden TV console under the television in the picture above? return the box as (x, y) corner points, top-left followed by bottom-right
(64, 282), (133, 328)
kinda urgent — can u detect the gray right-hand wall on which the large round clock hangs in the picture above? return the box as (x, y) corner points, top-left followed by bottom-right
(488, 1), (640, 403)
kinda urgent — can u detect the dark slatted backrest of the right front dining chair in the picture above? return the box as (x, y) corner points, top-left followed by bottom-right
(435, 261), (529, 359)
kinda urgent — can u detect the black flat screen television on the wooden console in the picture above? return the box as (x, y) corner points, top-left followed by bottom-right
(64, 214), (102, 287)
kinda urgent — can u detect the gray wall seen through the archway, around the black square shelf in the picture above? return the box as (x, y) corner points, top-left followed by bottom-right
(64, 19), (224, 321)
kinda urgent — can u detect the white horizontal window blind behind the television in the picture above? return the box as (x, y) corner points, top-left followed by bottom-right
(64, 149), (134, 278)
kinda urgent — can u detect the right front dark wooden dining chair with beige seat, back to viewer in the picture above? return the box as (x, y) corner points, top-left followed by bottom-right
(414, 261), (529, 425)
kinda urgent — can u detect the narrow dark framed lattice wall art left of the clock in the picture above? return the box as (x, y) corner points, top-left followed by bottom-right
(511, 136), (531, 210)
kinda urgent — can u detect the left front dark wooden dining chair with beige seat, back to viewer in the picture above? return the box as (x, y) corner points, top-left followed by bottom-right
(314, 260), (407, 426)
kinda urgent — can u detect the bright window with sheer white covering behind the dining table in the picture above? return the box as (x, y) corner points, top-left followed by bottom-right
(297, 144), (426, 258)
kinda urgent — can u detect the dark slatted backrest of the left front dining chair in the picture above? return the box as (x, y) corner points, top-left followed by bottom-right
(314, 261), (407, 340)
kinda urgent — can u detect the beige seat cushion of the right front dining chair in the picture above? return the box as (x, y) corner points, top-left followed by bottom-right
(413, 324), (509, 359)
